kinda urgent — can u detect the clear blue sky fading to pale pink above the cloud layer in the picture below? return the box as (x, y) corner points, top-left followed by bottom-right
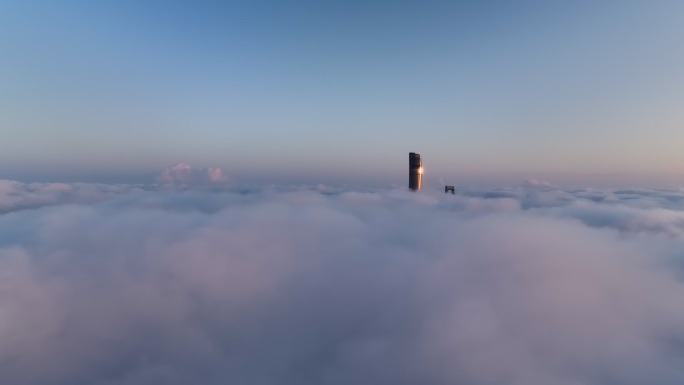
(0, 0), (684, 185)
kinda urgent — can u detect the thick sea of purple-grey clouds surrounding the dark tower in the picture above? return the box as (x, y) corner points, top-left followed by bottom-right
(0, 172), (684, 385)
